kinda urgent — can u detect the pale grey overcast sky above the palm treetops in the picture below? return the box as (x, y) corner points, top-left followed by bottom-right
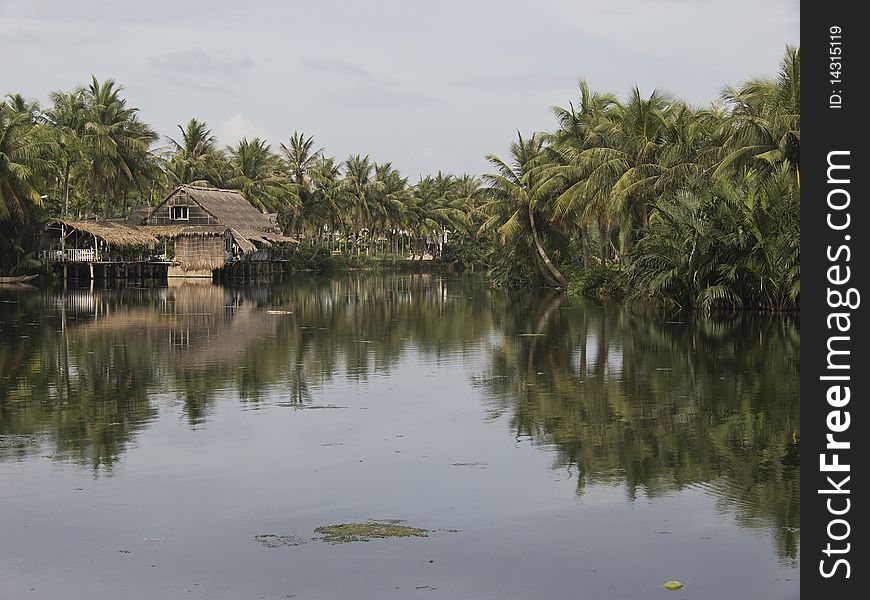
(0, 0), (800, 181)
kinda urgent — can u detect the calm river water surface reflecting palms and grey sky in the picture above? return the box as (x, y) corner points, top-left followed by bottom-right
(0, 275), (800, 600)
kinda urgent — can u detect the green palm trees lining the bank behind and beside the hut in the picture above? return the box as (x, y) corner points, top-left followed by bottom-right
(0, 48), (800, 310)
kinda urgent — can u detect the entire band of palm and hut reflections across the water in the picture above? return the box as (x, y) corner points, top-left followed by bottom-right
(0, 275), (800, 560)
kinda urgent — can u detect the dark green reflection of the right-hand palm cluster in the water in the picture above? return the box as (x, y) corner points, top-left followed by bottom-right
(478, 297), (800, 559)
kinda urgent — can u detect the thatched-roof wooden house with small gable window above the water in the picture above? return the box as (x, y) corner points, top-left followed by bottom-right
(140, 185), (296, 276)
